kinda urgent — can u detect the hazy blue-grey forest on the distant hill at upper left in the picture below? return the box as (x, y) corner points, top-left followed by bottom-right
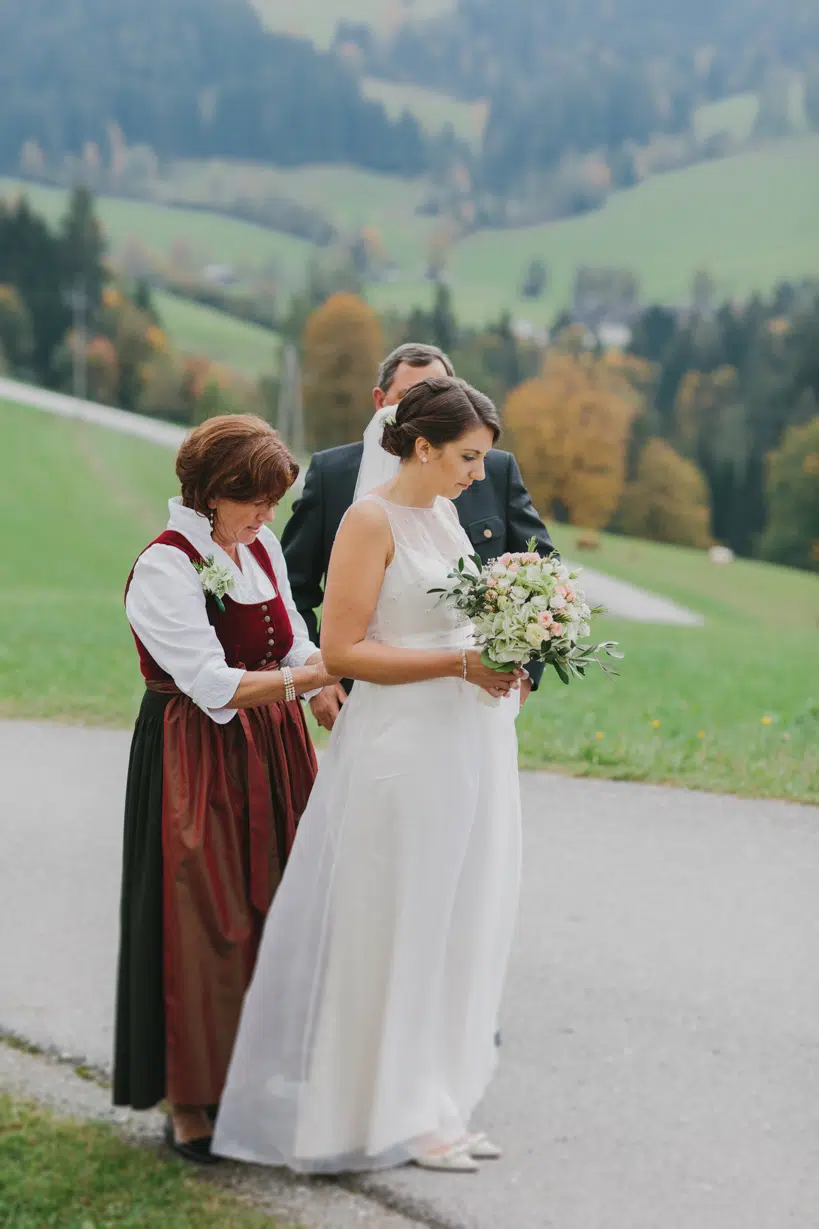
(0, 0), (425, 176)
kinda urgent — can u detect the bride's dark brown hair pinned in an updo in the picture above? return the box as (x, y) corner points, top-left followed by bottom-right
(381, 376), (501, 461)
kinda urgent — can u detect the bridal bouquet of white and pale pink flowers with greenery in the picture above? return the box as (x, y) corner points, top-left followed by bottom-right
(430, 540), (622, 683)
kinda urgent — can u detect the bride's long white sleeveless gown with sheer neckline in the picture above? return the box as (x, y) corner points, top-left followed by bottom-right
(214, 495), (520, 1172)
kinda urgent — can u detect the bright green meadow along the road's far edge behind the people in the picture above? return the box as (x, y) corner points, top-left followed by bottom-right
(0, 406), (819, 801)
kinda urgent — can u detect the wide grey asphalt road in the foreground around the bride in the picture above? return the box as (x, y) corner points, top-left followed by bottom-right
(0, 723), (819, 1229)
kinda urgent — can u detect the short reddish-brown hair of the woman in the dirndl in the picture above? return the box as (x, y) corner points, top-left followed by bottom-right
(176, 414), (299, 516)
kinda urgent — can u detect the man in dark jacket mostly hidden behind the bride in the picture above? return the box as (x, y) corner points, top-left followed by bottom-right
(282, 342), (555, 730)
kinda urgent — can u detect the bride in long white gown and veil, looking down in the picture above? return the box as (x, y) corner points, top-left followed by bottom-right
(213, 377), (520, 1172)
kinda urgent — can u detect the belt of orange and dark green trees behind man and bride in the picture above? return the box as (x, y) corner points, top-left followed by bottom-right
(303, 284), (819, 569)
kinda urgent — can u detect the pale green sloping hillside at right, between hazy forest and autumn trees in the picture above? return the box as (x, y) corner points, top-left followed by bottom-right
(373, 136), (819, 323)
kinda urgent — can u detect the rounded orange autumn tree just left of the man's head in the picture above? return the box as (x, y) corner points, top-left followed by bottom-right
(301, 293), (384, 449)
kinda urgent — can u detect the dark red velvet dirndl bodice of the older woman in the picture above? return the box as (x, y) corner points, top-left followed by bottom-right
(125, 530), (293, 682)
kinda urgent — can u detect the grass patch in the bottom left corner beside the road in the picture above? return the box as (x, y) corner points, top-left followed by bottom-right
(0, 1096), (283, 1229)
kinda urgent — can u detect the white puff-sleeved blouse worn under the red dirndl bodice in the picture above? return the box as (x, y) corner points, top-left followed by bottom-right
(125, 497), (319, 724)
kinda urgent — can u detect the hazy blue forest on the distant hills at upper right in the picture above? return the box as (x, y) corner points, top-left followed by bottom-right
(344, 0), (819, 200)
